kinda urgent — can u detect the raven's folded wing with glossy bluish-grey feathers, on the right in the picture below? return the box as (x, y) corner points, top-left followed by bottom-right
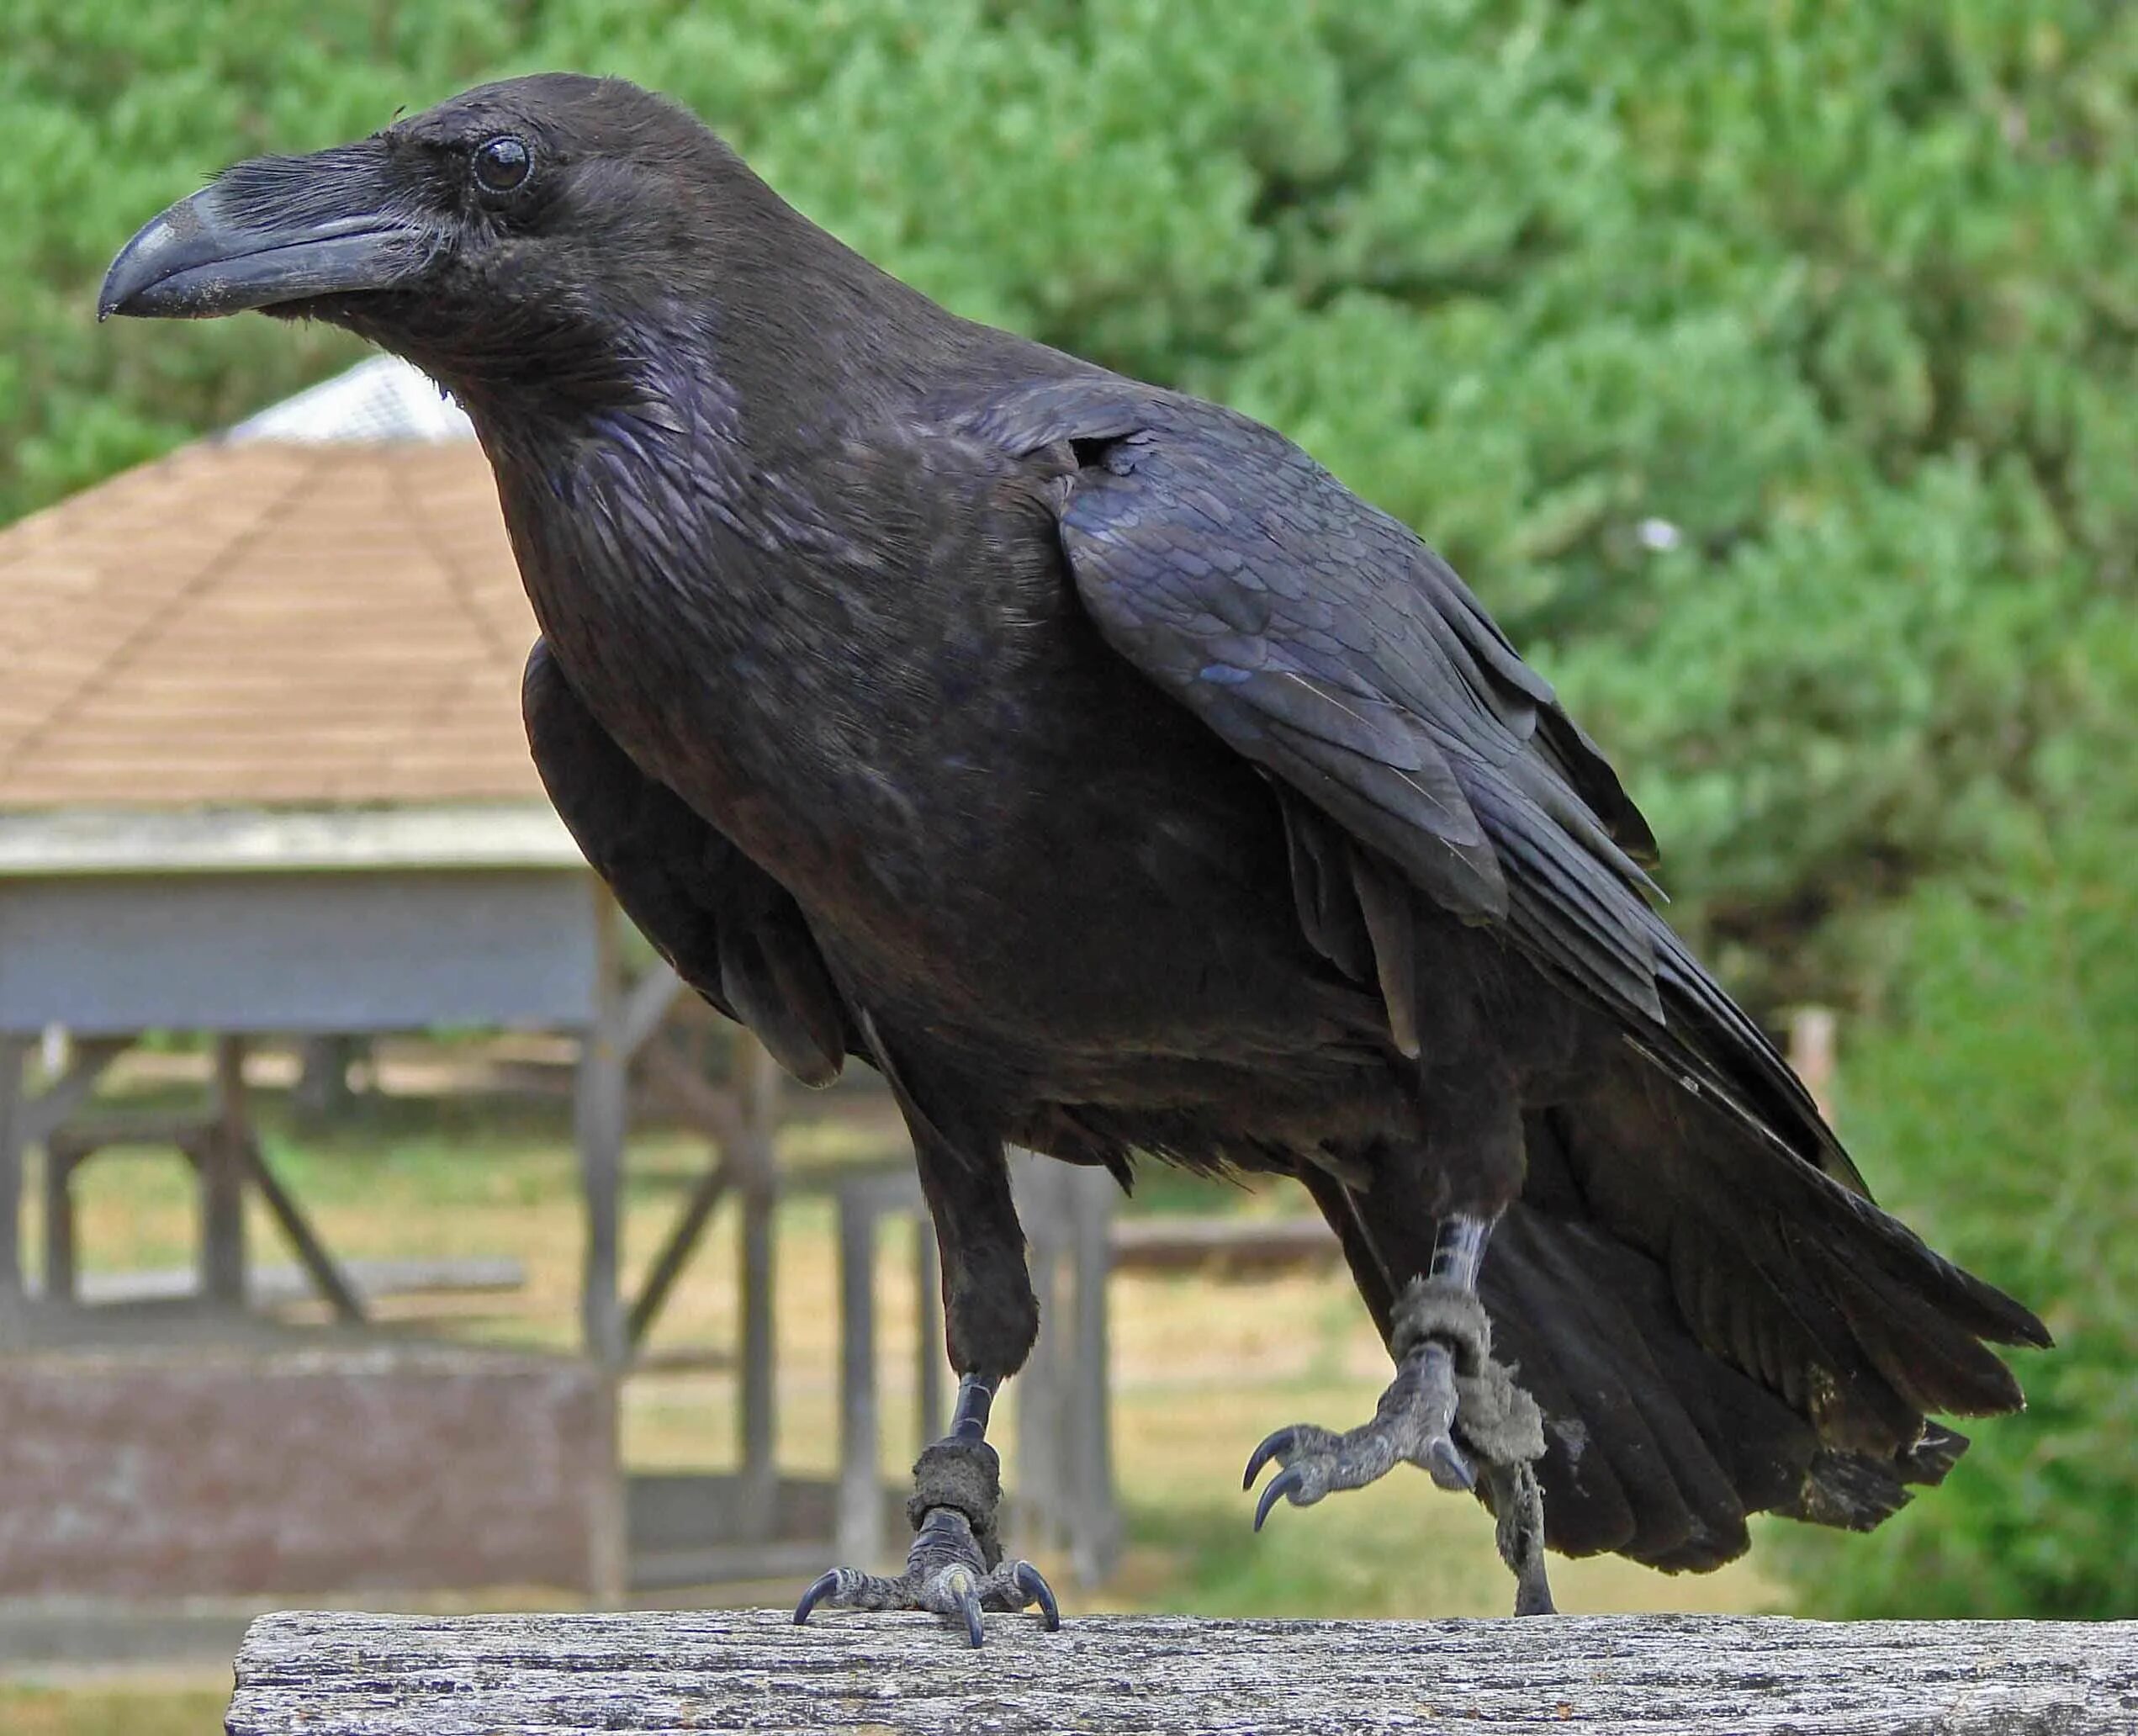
(977, 387), (1862, 1188)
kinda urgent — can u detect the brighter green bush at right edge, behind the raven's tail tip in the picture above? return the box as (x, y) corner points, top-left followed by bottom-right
(1770, 739), (2138, 1618)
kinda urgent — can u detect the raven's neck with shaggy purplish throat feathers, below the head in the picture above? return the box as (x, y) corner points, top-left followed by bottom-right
(468, 250), (962, 802)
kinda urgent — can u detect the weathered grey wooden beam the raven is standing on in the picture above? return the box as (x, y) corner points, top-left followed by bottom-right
(229, 1610), (2138, 1736)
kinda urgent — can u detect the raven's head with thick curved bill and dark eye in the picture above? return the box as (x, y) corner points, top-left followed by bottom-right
(98, 72), (778, 389)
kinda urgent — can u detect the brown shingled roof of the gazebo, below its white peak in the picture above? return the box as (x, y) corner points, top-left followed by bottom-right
(0, 441), (541, 810)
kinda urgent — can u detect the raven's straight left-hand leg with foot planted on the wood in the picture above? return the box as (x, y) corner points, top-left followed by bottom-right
(796, 1090), (1061, 1646)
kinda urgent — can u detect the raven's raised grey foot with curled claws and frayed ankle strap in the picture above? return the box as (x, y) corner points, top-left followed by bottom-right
(1242, 1278), (1552, 1617)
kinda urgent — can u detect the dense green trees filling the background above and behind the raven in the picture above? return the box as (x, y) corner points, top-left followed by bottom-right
(0, 0), (2138, 1607)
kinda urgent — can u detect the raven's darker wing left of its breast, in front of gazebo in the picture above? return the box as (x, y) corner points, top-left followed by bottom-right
(520, 639), (855, 1086)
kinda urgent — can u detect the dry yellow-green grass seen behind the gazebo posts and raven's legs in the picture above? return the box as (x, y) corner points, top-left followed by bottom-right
(0, 1052), (1776, 1736)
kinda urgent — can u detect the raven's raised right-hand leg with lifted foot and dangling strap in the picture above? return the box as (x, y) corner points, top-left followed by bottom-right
(1244, 1097), (1552, 1614)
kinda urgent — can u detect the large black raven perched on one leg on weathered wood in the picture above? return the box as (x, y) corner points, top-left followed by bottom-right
(100, 75), (2048, 1644)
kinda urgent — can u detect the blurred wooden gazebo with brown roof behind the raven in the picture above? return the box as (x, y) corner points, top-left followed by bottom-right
(0, 362), (718, 1593)
